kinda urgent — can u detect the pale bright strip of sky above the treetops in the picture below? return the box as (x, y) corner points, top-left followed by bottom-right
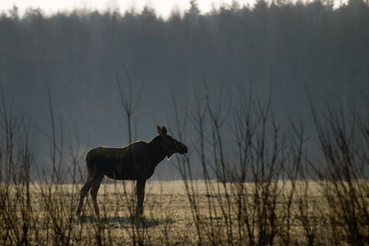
(0, 0), (255, 18)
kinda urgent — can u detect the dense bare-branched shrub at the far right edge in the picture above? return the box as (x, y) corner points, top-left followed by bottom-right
(311, 97), (369, 245)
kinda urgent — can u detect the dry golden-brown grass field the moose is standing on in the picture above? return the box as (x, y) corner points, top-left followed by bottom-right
(0, 181), (368, 245)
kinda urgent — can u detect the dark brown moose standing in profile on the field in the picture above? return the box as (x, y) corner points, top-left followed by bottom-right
(77, 126), (188, 216)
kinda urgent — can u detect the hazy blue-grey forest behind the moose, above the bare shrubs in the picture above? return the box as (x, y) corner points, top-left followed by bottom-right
(0, 0), (369, 181)
